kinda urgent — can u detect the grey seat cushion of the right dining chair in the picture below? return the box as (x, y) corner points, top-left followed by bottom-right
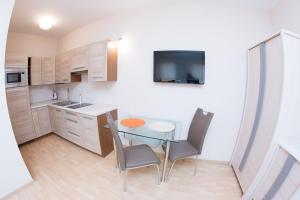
(162, 140), (198, 161)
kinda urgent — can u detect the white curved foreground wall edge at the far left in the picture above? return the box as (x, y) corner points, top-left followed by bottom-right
(0, 0), (32, 198)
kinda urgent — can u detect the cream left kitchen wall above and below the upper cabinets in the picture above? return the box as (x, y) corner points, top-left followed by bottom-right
(6, 32), (57, 102)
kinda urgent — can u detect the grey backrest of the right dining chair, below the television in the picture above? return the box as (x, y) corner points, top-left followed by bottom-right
(187, 108), (214, 154)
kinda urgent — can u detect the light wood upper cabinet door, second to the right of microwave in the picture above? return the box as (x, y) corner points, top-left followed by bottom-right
(42, 57), (55, 84)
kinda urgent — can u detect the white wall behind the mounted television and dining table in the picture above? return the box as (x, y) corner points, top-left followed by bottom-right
(58, 1), (272, 161)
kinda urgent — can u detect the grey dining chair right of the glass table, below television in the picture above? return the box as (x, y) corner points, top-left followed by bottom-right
(162, 108), (214, 181)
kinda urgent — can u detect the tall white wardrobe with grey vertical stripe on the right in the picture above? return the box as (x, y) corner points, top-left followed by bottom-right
(231, 31), (300, 199)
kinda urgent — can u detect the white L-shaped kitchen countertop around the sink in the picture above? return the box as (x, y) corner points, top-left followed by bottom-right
(31, 101), (117, 116)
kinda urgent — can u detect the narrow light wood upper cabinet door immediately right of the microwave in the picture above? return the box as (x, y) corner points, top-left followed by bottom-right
(30, 57), (42, 85)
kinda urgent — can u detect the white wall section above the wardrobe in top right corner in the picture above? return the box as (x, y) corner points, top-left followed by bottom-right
(271, 0), (300, 34)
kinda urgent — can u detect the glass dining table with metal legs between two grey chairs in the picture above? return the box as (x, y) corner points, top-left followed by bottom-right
(109, 115), (181, 182)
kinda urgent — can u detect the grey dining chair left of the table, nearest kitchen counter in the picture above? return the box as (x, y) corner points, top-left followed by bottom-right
(106, 112), (160, 192)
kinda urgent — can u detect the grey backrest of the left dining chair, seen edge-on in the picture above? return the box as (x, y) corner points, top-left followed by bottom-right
(106, 112), (126, 170)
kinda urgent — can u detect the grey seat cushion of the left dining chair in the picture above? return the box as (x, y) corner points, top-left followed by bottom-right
(124, 144), (160, 168)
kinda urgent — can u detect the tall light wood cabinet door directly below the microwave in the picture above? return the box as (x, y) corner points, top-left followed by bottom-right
(6, 87), (37, 144)
